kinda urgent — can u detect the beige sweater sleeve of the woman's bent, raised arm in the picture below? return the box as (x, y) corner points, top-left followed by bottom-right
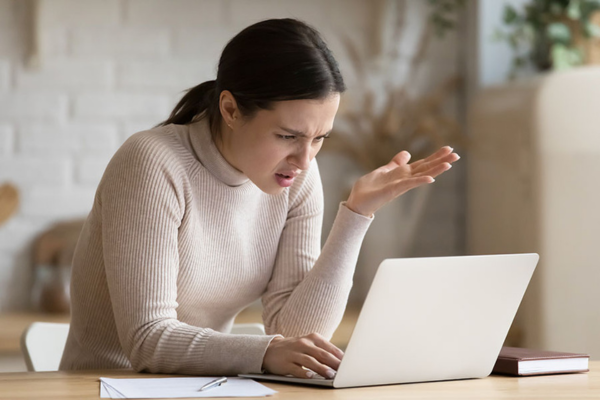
(262, 160), (372, 339)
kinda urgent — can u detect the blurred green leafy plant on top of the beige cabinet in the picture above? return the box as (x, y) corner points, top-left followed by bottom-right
(495, 0), (600, 76)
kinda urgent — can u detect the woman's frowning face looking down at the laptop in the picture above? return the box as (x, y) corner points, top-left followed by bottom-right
(217, 91), (340, 194)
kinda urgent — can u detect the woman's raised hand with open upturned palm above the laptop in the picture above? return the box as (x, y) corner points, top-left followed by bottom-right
(346, 146), (460, 216)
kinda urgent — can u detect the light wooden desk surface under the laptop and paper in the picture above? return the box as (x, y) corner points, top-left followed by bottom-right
(0, 361), (600, 400)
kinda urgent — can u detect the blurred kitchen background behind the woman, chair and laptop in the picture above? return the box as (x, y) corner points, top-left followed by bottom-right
(0, 0), (600, 371)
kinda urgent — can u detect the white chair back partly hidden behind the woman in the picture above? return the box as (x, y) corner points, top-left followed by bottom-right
(21, 322), (265, 371)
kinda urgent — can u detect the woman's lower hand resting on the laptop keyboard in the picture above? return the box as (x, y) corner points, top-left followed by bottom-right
(263, 333), (344, 378)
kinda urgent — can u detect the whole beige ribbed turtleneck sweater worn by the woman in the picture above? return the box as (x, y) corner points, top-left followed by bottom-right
(60, 121), (371, 375)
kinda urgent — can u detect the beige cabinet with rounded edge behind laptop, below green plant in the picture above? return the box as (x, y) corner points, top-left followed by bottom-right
(467, 67), (600, 359)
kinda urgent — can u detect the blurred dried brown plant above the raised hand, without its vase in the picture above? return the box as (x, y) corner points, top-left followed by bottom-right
(323, 0), (466, 171)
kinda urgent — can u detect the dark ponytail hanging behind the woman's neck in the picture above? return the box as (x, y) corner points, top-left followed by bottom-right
(156, 80), (218, 130)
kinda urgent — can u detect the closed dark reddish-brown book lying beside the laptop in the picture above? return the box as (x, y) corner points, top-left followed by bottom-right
(492, 347), (590, 376)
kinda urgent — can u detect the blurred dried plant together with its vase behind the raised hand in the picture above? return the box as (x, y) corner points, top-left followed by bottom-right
(323, 0), (466, 304)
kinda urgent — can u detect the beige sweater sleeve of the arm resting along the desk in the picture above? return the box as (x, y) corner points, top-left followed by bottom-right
(99, 136), (274, 375)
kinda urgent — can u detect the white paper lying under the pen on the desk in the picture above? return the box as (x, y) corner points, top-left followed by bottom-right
(100, 377), (277, 399)
